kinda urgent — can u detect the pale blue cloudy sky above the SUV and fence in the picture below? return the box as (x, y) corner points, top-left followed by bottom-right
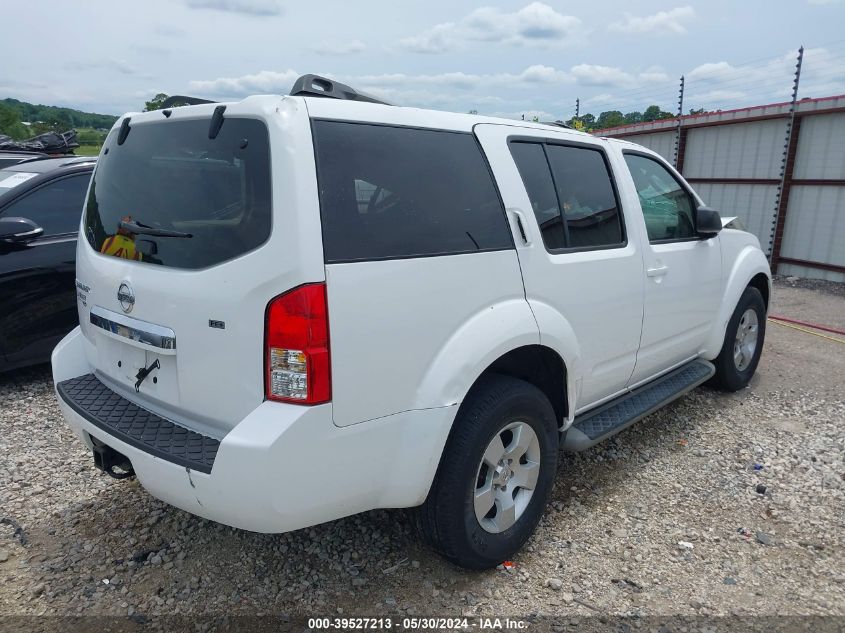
(0, 0), (845, 120)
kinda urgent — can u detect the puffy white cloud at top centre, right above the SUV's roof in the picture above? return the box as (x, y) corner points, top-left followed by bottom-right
(398, 2), (582, 53)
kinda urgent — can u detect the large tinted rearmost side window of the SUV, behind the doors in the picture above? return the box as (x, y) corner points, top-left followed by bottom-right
(313, 121), (513, 263)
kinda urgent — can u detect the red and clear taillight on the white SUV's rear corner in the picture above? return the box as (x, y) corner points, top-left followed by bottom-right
(264, 283), (332, 404)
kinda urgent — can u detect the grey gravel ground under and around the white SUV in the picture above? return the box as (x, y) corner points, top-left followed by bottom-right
(0, 280), (845, 617)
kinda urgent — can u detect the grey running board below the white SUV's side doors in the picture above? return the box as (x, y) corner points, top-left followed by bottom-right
(562, 360), (716, 451)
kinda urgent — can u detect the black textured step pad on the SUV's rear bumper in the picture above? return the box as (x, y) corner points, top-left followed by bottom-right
(56, 374), (220, 473)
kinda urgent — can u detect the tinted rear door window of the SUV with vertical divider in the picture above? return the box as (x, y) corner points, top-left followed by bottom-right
(510, 141), (625, 251)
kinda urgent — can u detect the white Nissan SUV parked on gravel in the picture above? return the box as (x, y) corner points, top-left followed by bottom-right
(52, 75), (770, 568)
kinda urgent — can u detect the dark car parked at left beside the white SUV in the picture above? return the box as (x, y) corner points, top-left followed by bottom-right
(0, 154), (96, 371)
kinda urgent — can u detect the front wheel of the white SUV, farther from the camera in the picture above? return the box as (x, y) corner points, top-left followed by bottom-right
(711, 286), (766, 391)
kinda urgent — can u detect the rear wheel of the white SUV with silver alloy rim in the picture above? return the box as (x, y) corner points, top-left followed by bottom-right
(416, 375), (559, 569)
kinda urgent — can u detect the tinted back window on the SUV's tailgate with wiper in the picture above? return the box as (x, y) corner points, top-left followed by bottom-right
(84, 118), (271, 268)
